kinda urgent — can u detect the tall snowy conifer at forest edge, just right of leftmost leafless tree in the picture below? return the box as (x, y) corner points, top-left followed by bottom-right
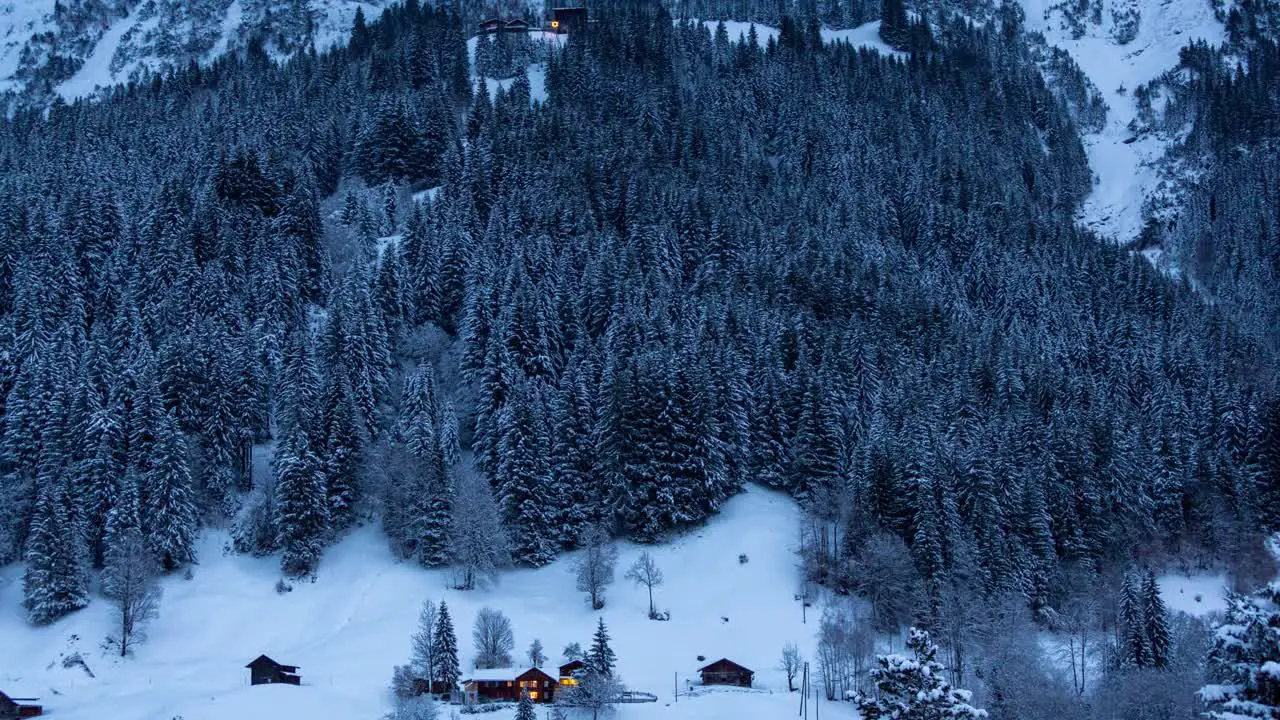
(141, 411), (198, 571)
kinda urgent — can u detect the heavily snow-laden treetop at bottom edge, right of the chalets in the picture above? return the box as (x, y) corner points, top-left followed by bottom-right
(856, 628), (987, 720)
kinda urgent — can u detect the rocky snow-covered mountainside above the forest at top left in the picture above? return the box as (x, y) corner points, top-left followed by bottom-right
(0, 0), (392, 102)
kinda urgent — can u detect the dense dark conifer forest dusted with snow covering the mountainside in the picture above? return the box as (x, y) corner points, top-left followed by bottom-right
(0, 0), (1280, 712)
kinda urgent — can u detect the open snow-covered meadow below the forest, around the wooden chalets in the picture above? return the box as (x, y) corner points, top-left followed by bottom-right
(0, 487), (854, 720)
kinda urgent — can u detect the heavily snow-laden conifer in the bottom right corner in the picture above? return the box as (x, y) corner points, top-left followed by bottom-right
(1198, 582), (1280, 720)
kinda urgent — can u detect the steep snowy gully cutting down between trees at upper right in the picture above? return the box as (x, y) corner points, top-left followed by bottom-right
(1021, 0), (1225, 242)
